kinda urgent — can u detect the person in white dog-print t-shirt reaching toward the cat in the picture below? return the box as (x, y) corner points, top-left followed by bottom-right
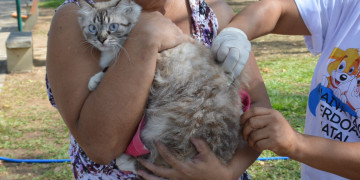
(213, 0), (360, 180)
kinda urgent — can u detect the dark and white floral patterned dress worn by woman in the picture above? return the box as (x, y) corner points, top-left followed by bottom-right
(45, 0), (250, 180)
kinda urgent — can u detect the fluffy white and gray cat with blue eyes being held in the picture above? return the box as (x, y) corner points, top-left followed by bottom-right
(79, 0), (243, 172)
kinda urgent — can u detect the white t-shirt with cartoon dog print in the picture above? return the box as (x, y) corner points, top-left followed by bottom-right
(295, 0), (360, 180)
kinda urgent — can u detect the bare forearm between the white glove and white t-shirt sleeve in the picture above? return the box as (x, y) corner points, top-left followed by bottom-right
(228, 0), (310, 40)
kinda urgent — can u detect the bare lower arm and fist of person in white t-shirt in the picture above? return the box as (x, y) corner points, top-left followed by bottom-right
(242, 108), (360, 179)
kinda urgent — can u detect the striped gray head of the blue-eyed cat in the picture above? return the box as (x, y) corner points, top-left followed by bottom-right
(79, 0), (141, 51)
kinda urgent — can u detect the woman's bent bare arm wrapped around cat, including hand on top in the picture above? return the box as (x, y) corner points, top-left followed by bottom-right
(47, 3), (190, 164)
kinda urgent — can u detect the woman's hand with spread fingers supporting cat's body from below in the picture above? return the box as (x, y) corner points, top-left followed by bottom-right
(138, 139), (232, 180)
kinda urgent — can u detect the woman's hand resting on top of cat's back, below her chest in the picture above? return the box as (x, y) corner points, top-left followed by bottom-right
(128, 11), (192, 51)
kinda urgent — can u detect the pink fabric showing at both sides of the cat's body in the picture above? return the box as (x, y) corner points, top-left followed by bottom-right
(125, 90), (251, 157)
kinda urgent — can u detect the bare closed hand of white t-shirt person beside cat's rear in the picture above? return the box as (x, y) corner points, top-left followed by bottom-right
(241, 107), (299, 156)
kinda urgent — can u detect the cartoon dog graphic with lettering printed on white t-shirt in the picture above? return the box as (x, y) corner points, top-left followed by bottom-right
(309, 48), (360, 141)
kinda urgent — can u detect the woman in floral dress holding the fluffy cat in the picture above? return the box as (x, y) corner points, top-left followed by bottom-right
(47, 0), (270, 179)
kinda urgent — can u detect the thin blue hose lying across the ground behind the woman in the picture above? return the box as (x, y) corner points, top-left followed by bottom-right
(0, 156), (290, 163)
